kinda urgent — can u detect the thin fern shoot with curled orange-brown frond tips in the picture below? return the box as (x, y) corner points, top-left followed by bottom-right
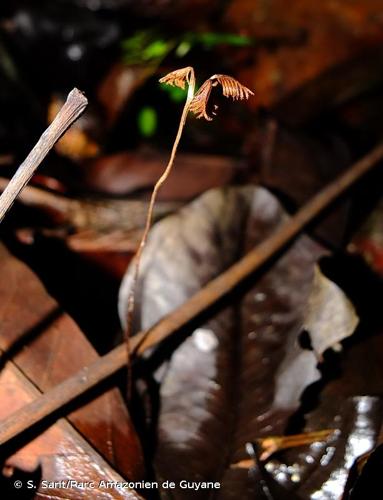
(125, 66), (253, 396)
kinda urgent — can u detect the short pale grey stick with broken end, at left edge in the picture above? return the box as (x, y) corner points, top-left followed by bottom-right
(0, 88), (88, 222)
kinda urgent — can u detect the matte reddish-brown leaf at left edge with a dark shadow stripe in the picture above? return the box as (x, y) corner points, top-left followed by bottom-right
(0, 245), (144, 479)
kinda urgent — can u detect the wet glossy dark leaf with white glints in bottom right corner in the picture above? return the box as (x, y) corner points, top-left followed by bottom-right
(260, 396), (383, 500)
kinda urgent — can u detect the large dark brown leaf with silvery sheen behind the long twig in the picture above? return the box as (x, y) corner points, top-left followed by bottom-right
(120, 187), (357, 498)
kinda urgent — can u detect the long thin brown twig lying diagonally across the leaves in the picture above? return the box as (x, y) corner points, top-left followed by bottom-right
(0, 144), (383, 444)
